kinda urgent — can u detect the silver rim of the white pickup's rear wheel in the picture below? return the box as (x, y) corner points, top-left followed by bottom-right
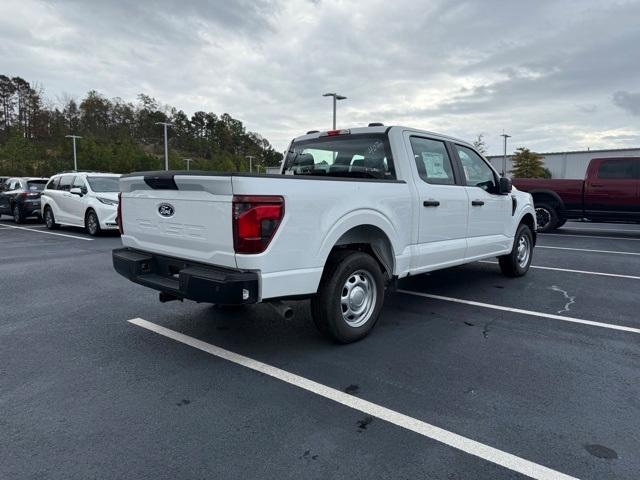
(340, 270), (377, 327)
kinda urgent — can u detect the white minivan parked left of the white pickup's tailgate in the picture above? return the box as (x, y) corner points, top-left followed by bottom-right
(41, 172), (120, 236)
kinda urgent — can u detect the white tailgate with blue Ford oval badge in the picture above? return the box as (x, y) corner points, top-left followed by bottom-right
(120, 172), (236, 268)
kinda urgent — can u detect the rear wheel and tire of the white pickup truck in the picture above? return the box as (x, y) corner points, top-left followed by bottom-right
(311, 250), (384, 343)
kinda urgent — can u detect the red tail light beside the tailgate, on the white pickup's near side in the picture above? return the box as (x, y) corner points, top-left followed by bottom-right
(233, 195), (284, 254)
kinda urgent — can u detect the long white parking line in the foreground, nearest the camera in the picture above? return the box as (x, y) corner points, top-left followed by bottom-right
(129, 318), (576, 480)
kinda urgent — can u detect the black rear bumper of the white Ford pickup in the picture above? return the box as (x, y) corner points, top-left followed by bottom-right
(112, 248), (259, 305)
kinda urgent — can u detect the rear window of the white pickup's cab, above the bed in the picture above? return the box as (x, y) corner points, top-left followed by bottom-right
(284, 134), (396, 180)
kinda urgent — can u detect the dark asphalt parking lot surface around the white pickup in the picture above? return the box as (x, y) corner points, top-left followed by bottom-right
(0, 217), (640, 479)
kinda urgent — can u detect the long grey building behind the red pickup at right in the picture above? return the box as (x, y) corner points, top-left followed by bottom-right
(487, 147), (640, 179)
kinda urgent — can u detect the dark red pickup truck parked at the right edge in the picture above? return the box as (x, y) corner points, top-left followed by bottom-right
(513, 157), (640, 232)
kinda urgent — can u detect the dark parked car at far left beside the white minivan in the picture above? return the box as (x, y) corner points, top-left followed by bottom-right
(0, 177), (48, 223)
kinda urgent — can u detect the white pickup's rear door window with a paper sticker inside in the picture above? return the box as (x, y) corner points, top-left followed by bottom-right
(411, 137), (456, 185)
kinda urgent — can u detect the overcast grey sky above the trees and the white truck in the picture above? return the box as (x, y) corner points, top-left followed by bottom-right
(0, 0), (640, 154)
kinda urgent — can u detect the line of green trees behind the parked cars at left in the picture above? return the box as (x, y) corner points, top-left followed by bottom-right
(0, 75), (282, 176)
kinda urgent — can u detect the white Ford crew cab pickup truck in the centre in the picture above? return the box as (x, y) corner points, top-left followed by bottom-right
(113, 124), (536, 343)
